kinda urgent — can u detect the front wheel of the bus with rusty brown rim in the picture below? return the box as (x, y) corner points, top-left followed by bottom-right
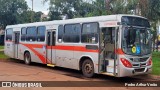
(82, 59), (94, 78)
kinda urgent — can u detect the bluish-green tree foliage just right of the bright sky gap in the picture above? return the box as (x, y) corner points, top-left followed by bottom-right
(44, 0), (82, 20)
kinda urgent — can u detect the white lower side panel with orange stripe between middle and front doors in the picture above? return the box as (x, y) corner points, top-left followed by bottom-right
(56, 43), (98, 73)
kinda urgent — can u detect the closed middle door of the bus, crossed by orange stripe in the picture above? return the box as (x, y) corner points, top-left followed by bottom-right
(46, 30), (56, 64)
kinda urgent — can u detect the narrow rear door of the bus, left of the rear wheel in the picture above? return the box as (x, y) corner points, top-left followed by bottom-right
(13, 32), (20, 59)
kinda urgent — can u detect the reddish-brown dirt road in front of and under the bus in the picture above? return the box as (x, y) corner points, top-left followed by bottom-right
(0, 59), (160, 90)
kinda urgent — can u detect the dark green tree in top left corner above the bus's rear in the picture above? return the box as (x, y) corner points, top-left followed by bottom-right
(0, 0), (28, 28)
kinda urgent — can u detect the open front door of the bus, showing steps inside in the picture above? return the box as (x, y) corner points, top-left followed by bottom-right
(99, 27), (118, 76)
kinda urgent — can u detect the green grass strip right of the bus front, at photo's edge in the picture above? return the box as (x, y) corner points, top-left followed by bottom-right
(152, 52), (160, 76)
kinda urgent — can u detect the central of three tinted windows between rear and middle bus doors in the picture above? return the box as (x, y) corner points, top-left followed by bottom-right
(26, 27), (37, 41)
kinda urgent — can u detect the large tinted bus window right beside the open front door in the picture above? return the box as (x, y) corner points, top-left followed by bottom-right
(81, 23), (98, 43)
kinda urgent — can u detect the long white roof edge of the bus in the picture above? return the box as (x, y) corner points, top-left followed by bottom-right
(6, 14), (146, 28)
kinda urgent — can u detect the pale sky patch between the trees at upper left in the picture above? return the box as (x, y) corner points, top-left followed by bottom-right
(25, 0), (49, 14)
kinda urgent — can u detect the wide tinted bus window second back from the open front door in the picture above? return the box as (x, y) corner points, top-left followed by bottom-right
(63, 24), (81, 43)
